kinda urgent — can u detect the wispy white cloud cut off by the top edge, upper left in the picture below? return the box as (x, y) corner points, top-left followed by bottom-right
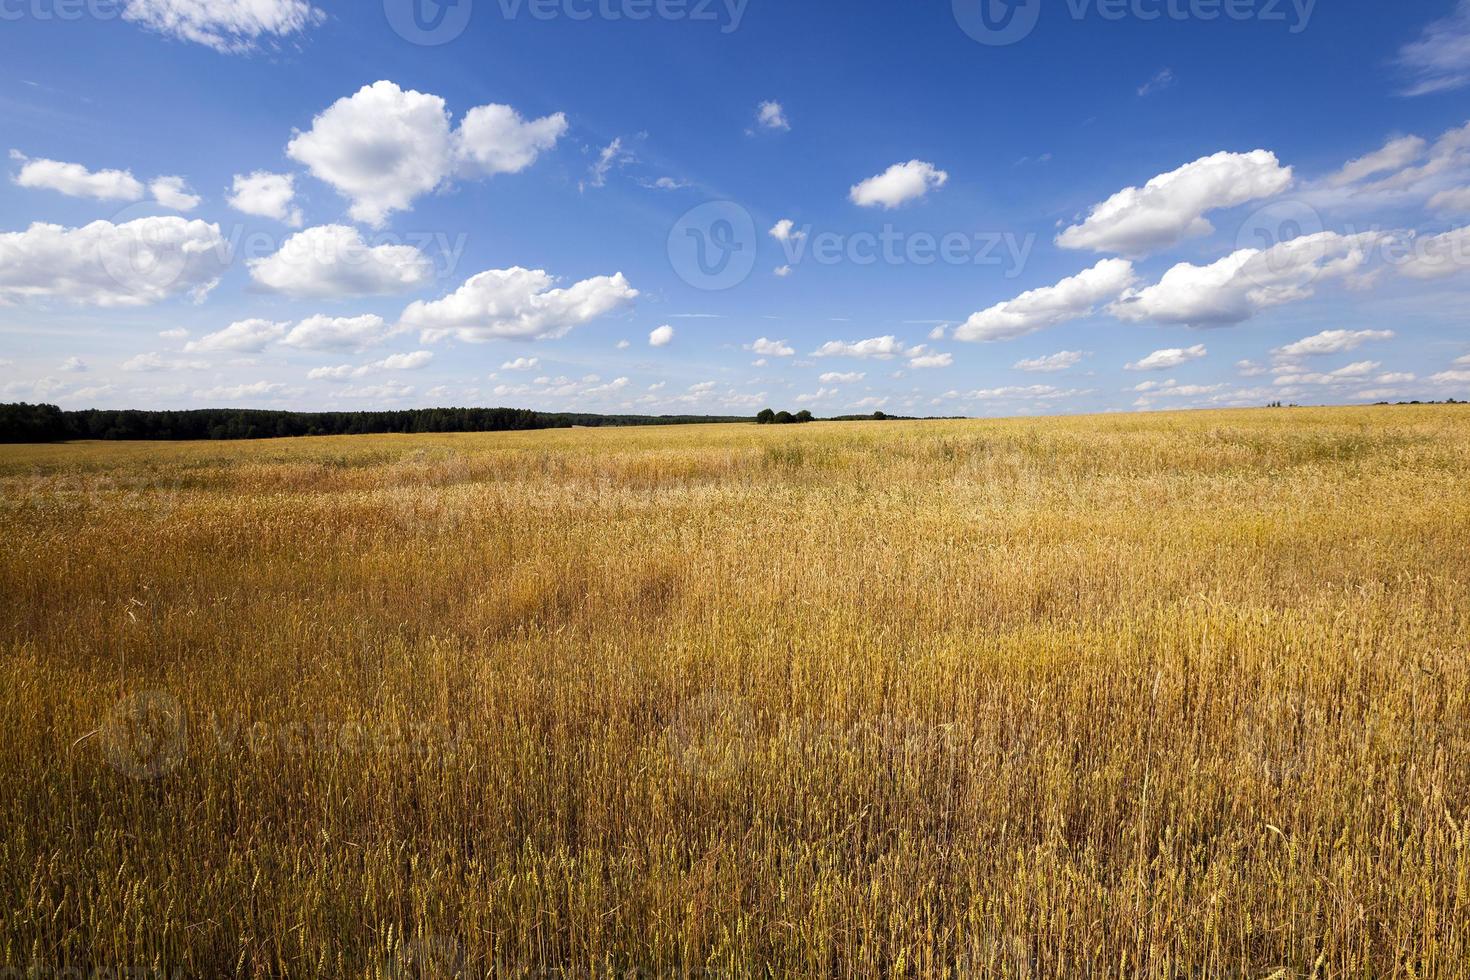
(122, 0), (326, 54)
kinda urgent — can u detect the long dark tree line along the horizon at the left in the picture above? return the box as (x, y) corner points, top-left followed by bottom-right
(0, 404), (750, 442)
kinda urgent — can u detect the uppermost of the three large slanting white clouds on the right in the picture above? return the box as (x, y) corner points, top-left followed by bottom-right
(1057, 150), (1292, 256)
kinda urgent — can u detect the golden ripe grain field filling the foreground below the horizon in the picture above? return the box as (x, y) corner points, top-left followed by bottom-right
(0, 407), (1470, 980)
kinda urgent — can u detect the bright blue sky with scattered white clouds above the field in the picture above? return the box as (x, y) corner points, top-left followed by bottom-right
(0, 0), (1470, 416)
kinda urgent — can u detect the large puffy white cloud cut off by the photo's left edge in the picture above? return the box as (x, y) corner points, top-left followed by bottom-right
(0, 217), (229, 307)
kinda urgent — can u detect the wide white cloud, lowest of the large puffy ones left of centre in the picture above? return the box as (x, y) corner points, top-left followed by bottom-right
(400, 266), (638, 344)
